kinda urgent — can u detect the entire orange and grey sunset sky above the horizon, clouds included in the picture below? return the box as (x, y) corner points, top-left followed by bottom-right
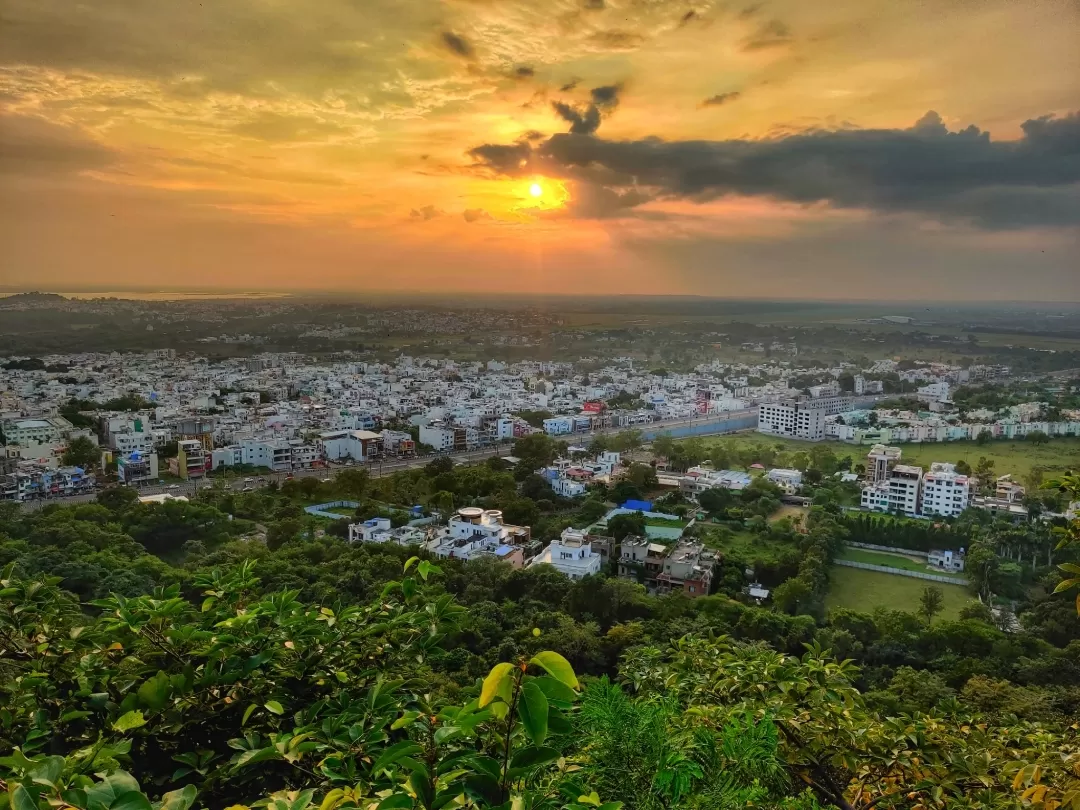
(0, 0), (1080, 301)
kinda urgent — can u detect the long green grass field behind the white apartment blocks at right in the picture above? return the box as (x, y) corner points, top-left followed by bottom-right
(710, 432), (1080, 482)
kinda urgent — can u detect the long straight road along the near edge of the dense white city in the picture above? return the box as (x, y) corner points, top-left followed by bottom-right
(22, 407), (757, 511)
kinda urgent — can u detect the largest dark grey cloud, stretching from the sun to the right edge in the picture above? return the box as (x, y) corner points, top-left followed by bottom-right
(472, 108), (1080, 229)
